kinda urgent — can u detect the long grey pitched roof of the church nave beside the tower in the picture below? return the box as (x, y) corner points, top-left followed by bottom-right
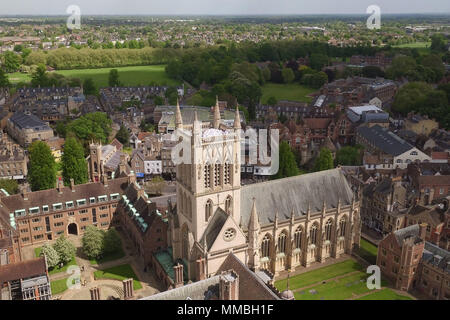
(241, 168), (353, 230)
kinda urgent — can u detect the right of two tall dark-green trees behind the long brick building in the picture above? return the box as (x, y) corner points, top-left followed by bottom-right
(61, 137), (88, 185)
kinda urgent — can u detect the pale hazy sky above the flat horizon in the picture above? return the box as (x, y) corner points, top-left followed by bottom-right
(0, 0), (450, 15)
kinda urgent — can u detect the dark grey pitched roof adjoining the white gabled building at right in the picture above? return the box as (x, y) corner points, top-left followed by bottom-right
(356, 125), (413, 156)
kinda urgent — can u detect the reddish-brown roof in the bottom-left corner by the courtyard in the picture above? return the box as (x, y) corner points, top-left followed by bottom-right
(0, 257), (47, 283)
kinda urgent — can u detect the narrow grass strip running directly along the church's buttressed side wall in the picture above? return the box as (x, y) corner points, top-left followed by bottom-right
(275, 259), (363, 291)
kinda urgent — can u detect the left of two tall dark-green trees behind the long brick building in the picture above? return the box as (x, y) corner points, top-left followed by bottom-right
(28, 140), (56, 191)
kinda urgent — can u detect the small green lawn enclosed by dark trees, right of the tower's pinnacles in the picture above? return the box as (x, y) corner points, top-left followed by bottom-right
(261, 83), (317, 103)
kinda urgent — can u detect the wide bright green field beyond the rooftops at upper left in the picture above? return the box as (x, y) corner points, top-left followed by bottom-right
(9, 65), (179, 88)
